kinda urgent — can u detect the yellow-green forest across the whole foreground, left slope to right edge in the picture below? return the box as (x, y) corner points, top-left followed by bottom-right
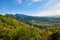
(0, 15), (60, 40)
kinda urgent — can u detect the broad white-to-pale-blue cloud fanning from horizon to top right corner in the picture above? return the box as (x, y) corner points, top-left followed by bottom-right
(34, 0), (60, 16)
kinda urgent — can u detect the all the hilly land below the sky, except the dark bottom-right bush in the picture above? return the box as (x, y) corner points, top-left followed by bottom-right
(0, 14), (60, 40)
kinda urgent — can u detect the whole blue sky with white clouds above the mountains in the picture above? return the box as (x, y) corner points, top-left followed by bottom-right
(0, 0), (60, 16)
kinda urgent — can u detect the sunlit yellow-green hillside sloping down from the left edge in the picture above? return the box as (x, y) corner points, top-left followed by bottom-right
(0, 15), (50, 40)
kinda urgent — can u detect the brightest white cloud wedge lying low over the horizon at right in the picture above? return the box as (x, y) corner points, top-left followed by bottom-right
(34, 9), (60, 16)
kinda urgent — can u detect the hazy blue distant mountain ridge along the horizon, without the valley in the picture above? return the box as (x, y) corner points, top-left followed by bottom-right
(15, 14), (60, 23)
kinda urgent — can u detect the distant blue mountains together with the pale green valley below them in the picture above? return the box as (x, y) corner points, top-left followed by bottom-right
(15, 14), (60, 28)
